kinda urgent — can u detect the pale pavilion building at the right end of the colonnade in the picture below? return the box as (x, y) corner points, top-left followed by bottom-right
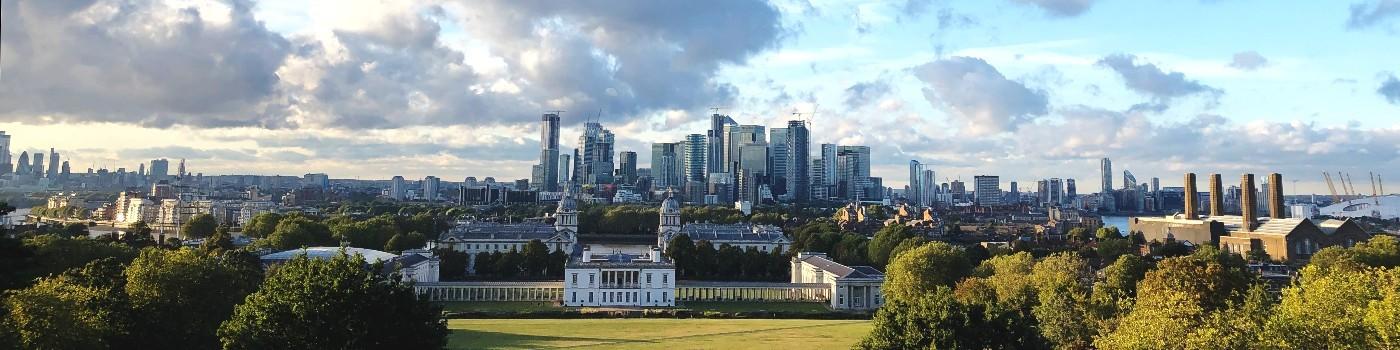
(791, 252), (885, 309)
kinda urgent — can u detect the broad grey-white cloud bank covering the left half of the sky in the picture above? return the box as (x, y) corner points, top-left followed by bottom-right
(0, 0), (785, 127)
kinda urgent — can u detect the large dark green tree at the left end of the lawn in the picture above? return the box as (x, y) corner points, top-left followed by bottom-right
(218, 252), (447, 349)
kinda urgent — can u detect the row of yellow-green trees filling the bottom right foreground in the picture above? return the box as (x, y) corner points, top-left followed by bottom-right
(858, 235), (1400, 349)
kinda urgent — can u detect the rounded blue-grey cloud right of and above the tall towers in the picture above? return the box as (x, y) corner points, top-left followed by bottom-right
(914, 56), (1049, 136)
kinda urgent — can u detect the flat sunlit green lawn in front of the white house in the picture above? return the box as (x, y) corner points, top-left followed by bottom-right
(448, 319), (871, 350)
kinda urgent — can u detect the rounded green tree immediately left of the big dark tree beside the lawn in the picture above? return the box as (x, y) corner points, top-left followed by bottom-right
(125, 248), (262, 349)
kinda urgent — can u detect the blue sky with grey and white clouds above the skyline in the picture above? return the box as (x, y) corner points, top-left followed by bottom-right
(0, 0), (1400, 193)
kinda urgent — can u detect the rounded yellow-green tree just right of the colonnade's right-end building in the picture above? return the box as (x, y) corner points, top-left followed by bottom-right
(882, 242), (972, 301)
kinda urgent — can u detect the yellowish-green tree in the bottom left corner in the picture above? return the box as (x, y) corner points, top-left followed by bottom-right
(4, 259), (129, 349)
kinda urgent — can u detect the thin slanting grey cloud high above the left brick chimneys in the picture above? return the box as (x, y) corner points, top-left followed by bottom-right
(1098, 53), (1224, 105)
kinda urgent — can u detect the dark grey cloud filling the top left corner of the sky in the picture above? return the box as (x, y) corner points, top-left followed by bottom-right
(0, 0), (290, 126)
